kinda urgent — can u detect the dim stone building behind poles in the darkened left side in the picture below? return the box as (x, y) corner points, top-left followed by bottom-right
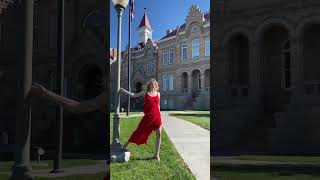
(0, 0), (106, 158)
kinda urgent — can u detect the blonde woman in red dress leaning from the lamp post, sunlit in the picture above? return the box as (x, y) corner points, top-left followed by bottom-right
(120, 78), (162, 161)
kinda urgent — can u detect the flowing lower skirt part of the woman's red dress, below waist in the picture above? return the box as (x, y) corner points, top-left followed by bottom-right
(128, 113), (162, 145)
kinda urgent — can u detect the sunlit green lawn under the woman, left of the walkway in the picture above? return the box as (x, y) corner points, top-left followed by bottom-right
(110, 115), (195, 180)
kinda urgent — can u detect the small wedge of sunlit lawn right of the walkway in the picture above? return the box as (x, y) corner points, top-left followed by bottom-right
(170, 111), (210, 131)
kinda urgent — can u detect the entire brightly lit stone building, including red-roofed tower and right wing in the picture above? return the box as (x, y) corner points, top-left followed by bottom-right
(116, 6), (210, 109)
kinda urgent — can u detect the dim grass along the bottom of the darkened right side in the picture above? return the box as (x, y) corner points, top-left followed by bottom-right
(211, 156), (320, 180)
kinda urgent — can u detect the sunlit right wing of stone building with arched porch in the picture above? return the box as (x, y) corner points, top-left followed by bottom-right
(157, 5), (210, 109)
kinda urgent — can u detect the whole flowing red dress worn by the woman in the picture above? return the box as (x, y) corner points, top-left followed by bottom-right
(128, 93), (162, 145)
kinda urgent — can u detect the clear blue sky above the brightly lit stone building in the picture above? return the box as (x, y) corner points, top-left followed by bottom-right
(110, 0), (210, 50)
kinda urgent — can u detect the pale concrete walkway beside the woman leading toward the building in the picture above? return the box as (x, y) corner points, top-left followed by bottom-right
(161, 111), (210, 180)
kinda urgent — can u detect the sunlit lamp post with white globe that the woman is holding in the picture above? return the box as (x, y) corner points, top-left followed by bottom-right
(110, 0), (130, 162)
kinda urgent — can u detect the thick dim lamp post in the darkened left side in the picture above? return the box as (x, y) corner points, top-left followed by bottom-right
(9, 0), (34, 180)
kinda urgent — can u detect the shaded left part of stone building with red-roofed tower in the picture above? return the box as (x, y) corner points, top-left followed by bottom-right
(121, 13), (158, 110)
